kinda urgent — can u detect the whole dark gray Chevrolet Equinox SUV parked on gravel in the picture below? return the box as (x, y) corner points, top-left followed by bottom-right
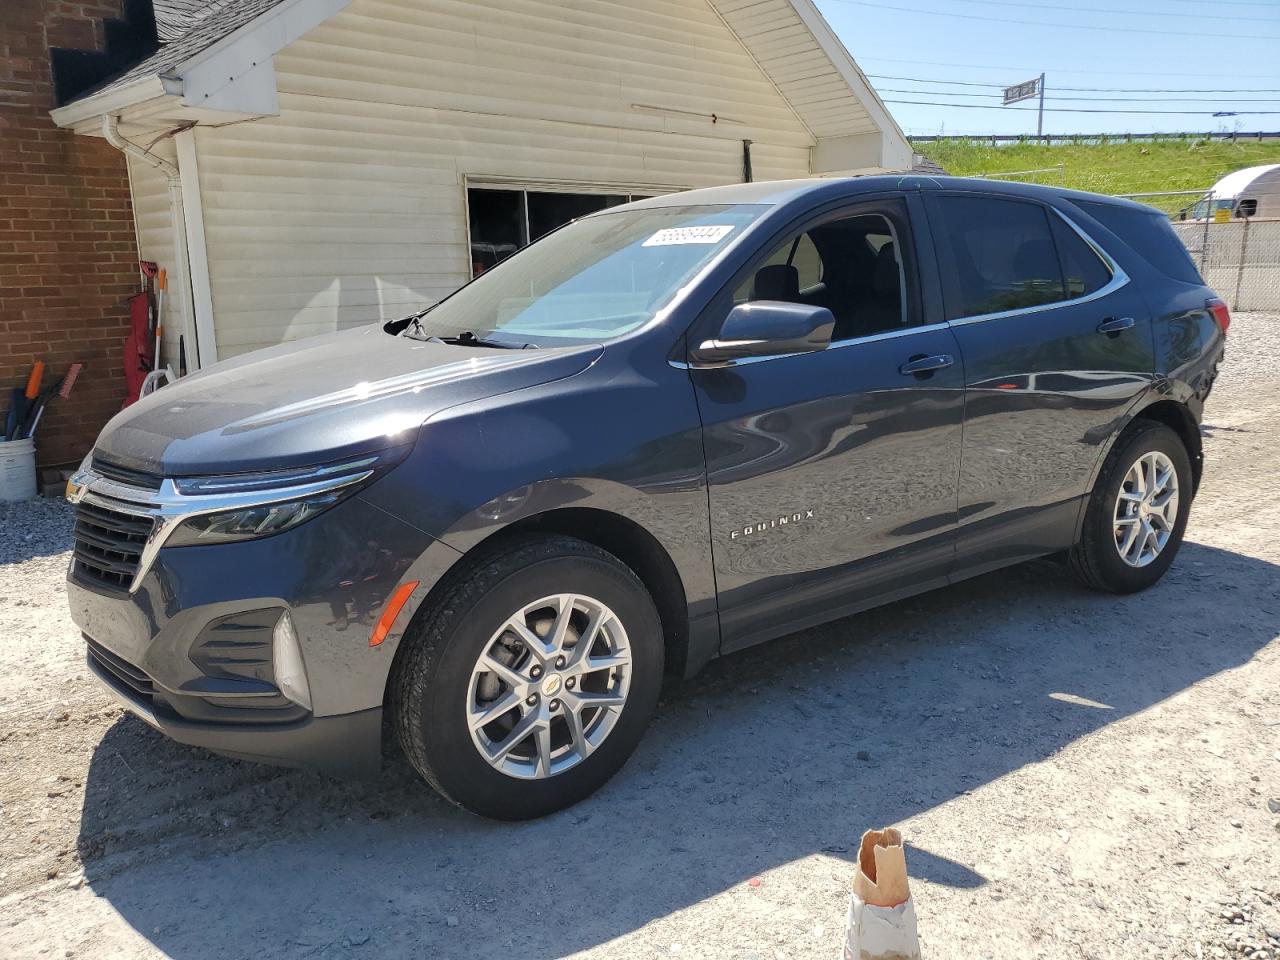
(69, 177), (1229, 818)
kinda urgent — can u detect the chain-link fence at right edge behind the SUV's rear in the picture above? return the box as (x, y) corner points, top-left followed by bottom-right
(1124, 191), (1280, 311)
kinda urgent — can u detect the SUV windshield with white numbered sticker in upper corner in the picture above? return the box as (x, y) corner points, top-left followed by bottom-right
(404, 204), (768, 346)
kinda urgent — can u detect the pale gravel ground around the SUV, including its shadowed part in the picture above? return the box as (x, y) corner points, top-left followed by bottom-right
(0, 314), (1280, 960)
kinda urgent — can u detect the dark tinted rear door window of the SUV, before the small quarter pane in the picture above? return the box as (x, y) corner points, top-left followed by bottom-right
(937, 193), (1071, 320)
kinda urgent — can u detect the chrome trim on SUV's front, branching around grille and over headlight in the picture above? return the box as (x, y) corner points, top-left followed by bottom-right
(68, 465), (374, 594)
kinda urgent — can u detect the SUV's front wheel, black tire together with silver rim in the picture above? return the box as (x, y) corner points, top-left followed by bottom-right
(390, 536), (663, 820)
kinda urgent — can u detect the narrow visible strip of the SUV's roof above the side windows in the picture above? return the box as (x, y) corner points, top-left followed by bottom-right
(622, 173), (1152, 212)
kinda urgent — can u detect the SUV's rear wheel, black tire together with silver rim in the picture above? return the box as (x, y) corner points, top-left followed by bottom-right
(1068, 420), (1193, 594)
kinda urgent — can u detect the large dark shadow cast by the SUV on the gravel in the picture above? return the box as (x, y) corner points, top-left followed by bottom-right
(79, 544), (1280, 960)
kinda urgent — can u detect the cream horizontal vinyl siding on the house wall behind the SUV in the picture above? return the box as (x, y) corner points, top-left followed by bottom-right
(196, 0), (814, 357)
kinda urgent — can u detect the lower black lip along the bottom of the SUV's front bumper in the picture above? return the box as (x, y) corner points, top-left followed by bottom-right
(87, 644), (383, 777)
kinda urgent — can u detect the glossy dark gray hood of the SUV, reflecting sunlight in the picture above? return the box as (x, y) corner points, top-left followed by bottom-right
(95, 325), (602, 476)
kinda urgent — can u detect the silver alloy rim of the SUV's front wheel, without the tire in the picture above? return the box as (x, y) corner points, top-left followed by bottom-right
(466, 594), (631, 780)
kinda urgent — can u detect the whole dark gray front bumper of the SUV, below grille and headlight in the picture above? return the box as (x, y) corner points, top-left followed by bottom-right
(67, 473), (458, 774)
